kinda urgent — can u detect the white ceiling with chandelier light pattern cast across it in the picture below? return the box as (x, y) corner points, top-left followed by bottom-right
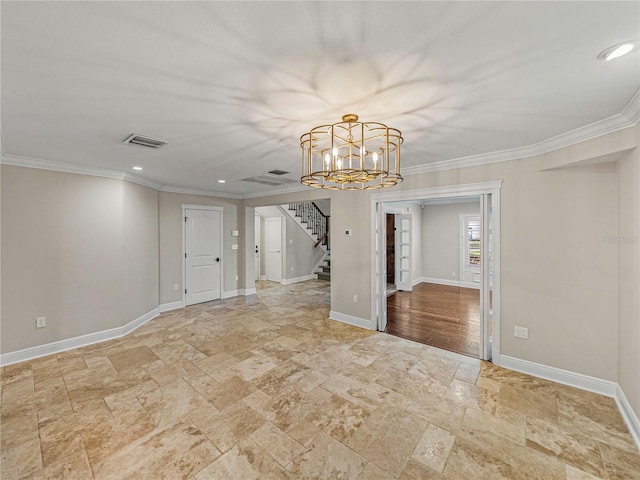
(1, 0), (640, 196)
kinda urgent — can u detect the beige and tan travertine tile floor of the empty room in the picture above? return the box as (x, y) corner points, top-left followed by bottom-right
(0, 281), (640, 480)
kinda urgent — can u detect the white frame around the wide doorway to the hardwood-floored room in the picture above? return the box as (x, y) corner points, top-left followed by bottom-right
(370, 180), (502, 365)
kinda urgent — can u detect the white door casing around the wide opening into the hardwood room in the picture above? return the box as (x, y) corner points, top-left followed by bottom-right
(371, 181), (502, 363)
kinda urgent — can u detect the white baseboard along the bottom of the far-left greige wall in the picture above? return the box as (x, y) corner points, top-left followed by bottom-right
(0, 308), (160, 367)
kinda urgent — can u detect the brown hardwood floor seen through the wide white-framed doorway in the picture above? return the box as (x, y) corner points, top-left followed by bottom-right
(387, 283), (480, 358)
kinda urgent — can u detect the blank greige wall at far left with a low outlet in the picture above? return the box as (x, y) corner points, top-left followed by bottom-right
(0, 165), (158, 354)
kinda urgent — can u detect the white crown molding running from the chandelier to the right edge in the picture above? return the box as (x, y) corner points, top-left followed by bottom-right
(402, 89), (640, 175)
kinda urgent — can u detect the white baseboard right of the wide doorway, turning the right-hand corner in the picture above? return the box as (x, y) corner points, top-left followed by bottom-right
(500, 355), (640, 450)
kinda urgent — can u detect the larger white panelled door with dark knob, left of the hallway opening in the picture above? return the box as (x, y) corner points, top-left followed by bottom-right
(184, 208), (222, 305)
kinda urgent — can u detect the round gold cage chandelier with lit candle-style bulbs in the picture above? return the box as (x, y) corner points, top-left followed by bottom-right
(300, 113), (402, 190)
